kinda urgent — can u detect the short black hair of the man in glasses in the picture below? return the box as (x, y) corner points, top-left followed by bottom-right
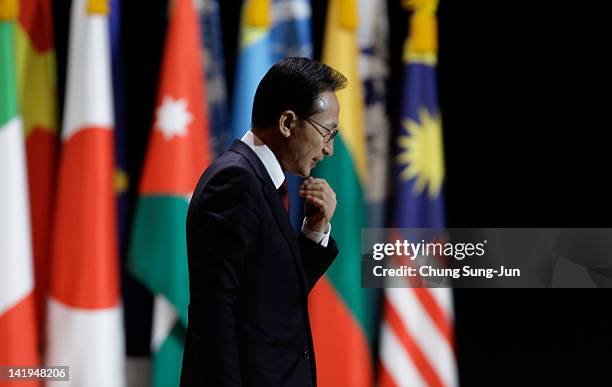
(251, 57), (347, 129)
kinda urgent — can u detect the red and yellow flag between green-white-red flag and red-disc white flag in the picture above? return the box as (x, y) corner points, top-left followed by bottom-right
(15, 0), (58, 348)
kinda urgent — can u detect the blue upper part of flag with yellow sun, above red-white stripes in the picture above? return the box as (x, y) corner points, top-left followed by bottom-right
(393, 2), (444, 228)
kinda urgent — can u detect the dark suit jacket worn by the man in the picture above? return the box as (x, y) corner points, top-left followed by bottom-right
(181, 141), (338, 387)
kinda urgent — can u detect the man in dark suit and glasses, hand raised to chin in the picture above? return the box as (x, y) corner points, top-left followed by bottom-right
(181, 58), (347, 387)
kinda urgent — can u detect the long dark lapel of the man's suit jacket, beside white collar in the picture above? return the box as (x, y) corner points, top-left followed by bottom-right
(230, 140), (307, 291)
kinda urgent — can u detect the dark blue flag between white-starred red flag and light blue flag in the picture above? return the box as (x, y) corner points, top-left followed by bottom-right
(196, 0), (232, 156)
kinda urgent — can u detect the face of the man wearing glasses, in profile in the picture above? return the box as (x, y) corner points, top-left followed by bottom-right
(287, 91), (340, 177)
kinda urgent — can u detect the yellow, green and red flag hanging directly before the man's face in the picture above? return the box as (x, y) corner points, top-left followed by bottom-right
(310, 0), (372, 387)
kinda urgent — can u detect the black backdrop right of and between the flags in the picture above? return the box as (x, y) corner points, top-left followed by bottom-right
(54, 0), (612, 387)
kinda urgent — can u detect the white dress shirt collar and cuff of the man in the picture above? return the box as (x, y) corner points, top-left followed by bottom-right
(241, 130), (331, 247)
